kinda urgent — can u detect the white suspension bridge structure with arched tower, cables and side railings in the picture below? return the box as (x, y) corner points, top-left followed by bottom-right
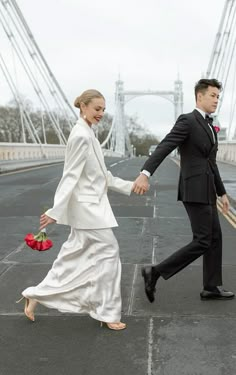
(0, 0), (236, 163)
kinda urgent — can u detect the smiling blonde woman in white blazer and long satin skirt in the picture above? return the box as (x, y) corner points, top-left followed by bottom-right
(19, 90), (133, 330)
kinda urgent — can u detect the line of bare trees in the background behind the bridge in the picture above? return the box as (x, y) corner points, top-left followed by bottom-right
(0, 96), (159, 155)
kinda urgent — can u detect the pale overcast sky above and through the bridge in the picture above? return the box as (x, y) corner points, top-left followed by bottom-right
(0, 0), (231, 136)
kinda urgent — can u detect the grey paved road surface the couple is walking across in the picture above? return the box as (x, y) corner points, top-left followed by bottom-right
(0, 158), (236, 375)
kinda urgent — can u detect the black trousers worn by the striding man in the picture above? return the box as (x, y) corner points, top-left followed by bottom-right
(153, 202), (222, 287)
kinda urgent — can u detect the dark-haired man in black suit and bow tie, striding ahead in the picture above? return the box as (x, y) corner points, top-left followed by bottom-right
(133, 79), (234, 302)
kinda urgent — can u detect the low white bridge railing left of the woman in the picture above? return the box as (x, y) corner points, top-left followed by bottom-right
(0, 142), (66, 161)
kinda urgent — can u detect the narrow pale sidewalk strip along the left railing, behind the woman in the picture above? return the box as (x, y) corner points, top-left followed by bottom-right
(0, 159), (64, 174)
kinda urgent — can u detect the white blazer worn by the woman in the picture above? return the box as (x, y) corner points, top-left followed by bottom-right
(46, 118), (133, 229)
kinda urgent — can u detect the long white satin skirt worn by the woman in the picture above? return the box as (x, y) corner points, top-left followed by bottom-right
(22, 228), (121, 323)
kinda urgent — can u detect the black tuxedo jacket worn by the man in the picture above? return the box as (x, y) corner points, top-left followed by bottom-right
(142, 110), (226, 204)
